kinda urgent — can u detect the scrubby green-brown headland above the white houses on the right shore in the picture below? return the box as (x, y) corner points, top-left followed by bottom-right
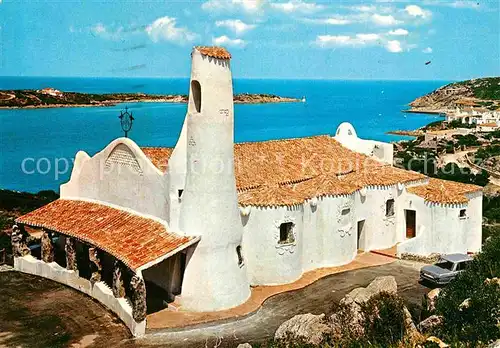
(410, 77), (500, 111)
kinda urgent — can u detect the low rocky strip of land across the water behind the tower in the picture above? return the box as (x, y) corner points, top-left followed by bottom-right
(0, 88), (302, 109)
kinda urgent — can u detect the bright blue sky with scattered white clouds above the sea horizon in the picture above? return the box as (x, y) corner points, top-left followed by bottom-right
(0, 0), (500, 80)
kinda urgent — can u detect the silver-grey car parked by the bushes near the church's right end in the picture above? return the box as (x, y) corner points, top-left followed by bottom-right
(420, 254), (472, 285)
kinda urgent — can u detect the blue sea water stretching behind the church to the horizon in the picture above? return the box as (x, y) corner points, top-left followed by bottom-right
(0, 77), (447, 192)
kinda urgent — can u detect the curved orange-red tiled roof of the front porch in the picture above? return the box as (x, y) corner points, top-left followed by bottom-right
(16, 199), (195, 270)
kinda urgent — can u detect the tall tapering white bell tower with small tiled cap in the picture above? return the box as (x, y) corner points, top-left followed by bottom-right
(179, 47), (250, 311)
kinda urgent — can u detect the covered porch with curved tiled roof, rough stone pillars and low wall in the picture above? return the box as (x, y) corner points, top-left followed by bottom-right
(12, 199), (199, 336)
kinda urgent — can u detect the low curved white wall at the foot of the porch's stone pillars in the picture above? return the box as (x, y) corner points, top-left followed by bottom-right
(14, 255), (146, 337)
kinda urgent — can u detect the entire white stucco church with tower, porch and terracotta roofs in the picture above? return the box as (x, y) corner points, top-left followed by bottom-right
(13, 47), (482, 336)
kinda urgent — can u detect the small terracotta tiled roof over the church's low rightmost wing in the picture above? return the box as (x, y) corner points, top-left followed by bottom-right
(408, 178), (482, 204)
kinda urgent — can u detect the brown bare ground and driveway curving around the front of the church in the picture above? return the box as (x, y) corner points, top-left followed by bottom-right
(0, 261), (429, 348)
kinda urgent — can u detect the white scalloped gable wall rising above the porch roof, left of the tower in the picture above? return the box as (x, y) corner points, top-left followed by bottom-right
(61, 138), (169, 222)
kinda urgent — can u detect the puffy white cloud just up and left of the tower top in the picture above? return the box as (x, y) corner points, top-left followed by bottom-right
(146, 16), (197, 43)
